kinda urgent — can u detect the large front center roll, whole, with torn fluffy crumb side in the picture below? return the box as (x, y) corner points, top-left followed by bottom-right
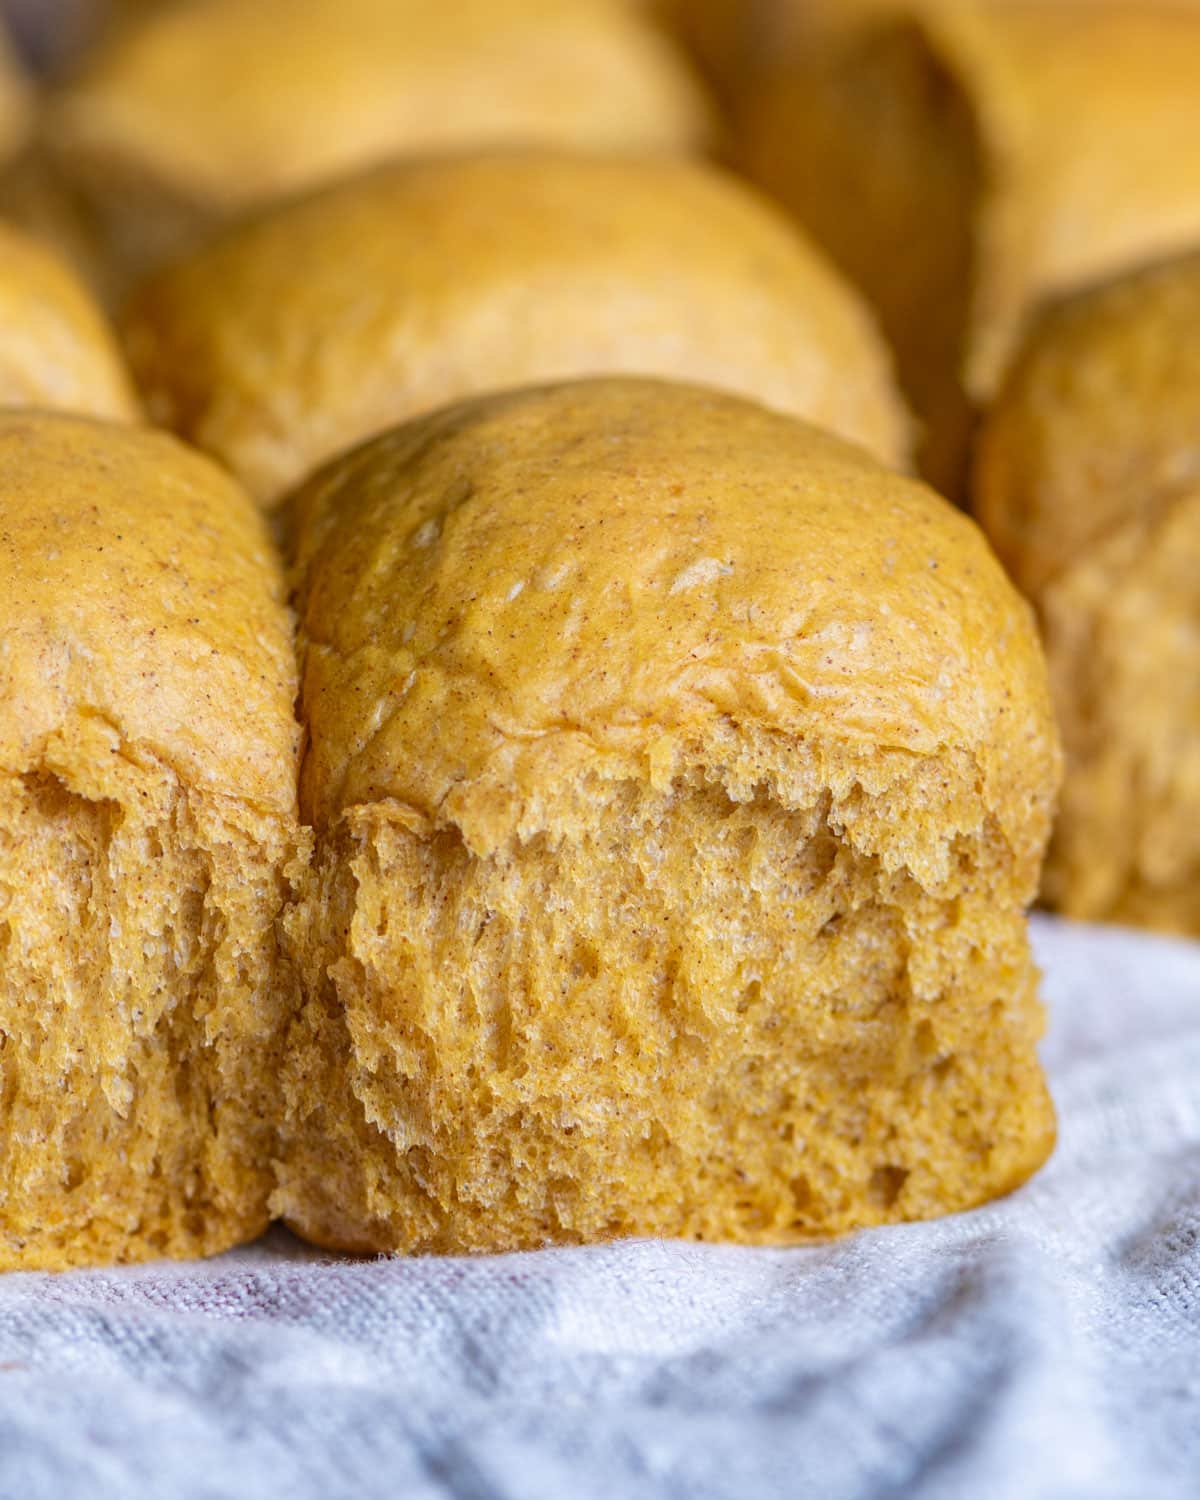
(275, 381), (1058, 1251)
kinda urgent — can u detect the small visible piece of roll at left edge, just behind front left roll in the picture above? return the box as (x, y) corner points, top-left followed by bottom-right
(0, 224), (138, 422)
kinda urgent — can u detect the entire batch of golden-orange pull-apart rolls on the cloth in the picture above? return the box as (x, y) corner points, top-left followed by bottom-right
(0, 0), (1200, 1268)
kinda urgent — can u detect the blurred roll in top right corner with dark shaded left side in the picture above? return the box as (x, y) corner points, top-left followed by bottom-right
(743, 0), (1200, 489)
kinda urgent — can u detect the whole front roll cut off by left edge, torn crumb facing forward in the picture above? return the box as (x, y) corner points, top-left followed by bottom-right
(0, 411), (299, 1269)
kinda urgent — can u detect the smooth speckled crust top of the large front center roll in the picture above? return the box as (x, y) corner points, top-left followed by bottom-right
(288, 380), (1056, 848)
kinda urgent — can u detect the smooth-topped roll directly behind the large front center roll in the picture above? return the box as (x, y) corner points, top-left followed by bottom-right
(125, 150), (908, 503)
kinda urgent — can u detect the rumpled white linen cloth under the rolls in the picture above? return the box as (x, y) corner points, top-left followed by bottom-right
(0, 920), (1200, 1500)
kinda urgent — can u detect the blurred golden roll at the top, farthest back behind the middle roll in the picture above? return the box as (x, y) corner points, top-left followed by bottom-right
(47, 0), (708, 294)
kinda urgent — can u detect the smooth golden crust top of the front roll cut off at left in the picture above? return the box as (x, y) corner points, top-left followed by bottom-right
(0, 411), (296, 815)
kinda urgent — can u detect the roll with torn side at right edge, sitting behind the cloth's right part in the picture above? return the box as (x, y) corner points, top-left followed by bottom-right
(975, 255), (1200, 936)
